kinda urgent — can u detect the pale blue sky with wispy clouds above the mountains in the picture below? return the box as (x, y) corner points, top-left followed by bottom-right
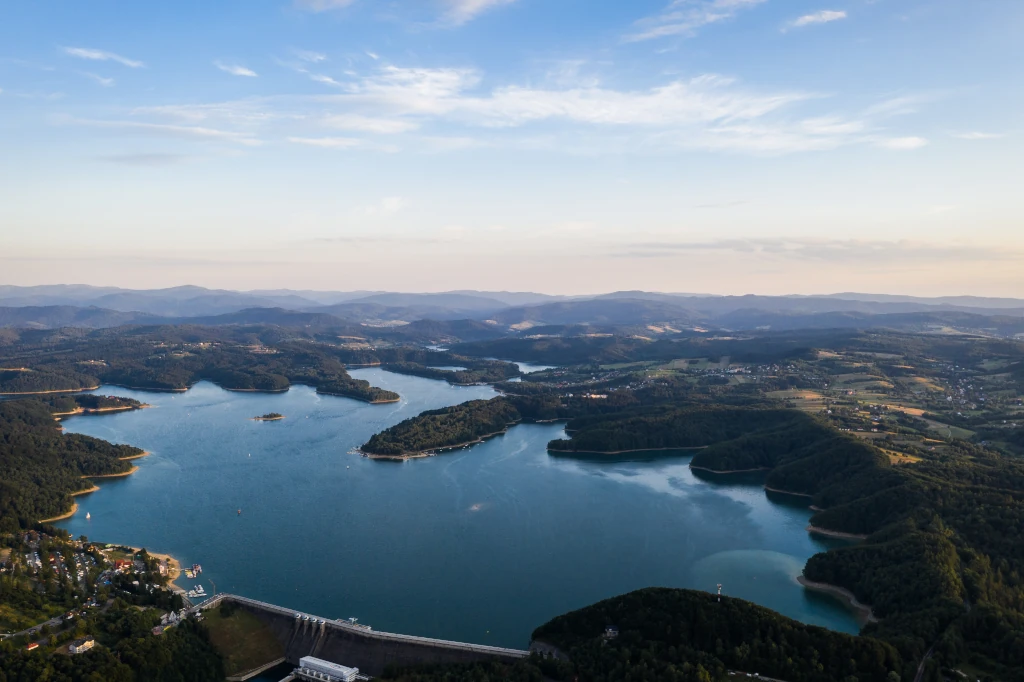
(0, 0), (1024, 297)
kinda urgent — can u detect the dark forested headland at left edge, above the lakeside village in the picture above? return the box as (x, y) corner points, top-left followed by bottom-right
(0, 399), (142, 530)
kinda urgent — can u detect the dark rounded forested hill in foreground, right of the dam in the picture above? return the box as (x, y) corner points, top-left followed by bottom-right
(534, 588), (912, 682)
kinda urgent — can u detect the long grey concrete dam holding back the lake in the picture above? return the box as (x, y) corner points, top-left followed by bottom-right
(198, 594), (529, 676)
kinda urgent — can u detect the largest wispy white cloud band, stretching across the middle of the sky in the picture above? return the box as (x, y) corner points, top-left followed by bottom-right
(99, 65), (928, 155)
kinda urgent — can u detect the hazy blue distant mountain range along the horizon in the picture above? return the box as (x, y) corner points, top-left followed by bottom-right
(0, 285), (1024, 340)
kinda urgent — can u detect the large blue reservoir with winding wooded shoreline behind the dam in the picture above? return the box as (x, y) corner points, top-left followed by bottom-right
(59, 369), (859, 647)
